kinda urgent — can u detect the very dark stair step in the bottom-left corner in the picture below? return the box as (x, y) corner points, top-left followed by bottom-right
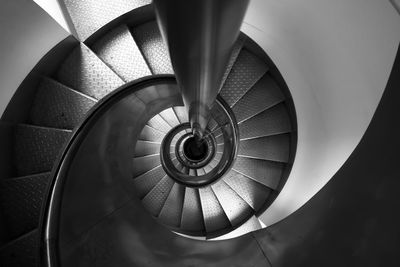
(0, 230), (39, 267)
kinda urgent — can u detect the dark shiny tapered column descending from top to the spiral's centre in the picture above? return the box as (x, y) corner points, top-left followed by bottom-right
(153, 0), (249, 137)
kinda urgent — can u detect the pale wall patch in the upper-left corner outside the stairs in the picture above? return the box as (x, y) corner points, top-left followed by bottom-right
(0, 0), (69, 115)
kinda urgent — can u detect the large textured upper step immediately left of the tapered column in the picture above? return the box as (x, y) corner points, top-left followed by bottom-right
(131, 21), (174, 74)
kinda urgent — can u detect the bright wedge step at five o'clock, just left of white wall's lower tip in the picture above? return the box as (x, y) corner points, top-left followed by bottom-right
(211, 180), (253, 226)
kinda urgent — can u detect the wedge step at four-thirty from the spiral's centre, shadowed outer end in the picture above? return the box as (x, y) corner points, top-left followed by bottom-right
(223, 170), (271, 211)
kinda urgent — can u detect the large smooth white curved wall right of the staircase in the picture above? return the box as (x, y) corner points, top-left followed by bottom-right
(243, 0), (400, 226)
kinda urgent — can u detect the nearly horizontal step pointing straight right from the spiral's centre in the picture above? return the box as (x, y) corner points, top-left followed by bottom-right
(238, 134), (290, 162)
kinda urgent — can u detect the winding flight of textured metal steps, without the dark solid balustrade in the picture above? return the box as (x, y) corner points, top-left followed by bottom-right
(0, 1), (296, 267)
